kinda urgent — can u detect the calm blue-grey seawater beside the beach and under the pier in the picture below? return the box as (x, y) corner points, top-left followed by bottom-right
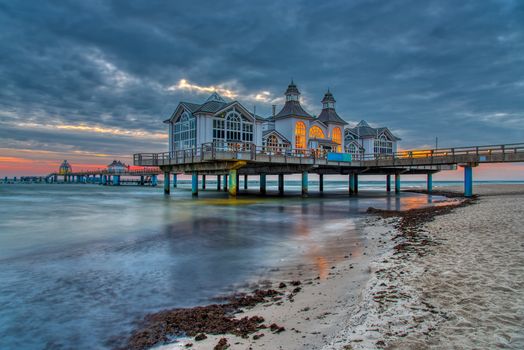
(0, 181), (448, 349)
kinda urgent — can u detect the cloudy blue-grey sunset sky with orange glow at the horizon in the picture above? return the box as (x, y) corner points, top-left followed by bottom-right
(0, 0), (524, 179)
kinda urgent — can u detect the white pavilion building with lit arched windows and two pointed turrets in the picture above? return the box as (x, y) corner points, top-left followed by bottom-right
(164, 82), (400, 158)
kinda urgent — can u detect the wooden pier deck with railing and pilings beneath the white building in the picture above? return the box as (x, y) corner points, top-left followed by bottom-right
(133, 143), (524, 197)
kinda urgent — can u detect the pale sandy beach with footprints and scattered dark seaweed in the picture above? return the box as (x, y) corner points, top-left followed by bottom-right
(131, 185), (524, 350)
